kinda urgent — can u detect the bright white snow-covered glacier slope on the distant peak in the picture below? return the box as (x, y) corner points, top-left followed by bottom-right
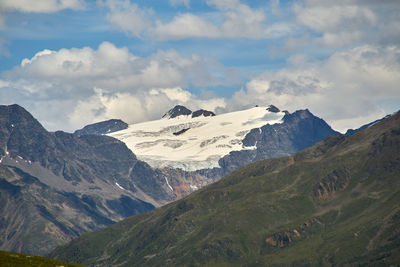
(109, 107), (285, 171)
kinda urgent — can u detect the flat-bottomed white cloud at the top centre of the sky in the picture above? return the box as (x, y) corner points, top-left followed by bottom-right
(101, 0), (293, 40)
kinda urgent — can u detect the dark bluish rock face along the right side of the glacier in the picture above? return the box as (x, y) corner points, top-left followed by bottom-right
(219, 109), (339, 175)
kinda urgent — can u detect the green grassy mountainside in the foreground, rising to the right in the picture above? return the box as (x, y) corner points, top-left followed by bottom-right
(51, 113), (400, 266)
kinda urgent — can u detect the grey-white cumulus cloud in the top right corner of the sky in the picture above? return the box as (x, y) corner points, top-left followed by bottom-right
(293, 0), (400, 47)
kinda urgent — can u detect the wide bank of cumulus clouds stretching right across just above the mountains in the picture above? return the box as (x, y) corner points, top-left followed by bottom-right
(0, 42), (400, 131)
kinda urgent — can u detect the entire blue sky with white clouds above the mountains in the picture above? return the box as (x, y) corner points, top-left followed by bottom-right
(0, 0), (400, 132)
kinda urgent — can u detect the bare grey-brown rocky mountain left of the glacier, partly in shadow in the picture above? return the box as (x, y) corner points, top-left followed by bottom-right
(0, 105), (176, 255)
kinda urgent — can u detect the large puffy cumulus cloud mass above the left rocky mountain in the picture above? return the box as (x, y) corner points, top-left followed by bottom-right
(0, 42), (234, 131)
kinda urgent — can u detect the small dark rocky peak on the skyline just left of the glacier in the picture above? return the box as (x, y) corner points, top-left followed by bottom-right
(74, 119), (128, 136)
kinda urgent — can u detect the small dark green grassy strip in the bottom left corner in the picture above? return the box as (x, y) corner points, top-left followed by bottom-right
(0, 250), (82, 267)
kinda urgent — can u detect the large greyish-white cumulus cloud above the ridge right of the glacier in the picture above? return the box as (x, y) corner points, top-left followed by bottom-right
(231, 45), (400, 131)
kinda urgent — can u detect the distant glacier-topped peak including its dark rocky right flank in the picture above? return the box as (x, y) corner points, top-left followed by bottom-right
(109, 105), (338, 172)
